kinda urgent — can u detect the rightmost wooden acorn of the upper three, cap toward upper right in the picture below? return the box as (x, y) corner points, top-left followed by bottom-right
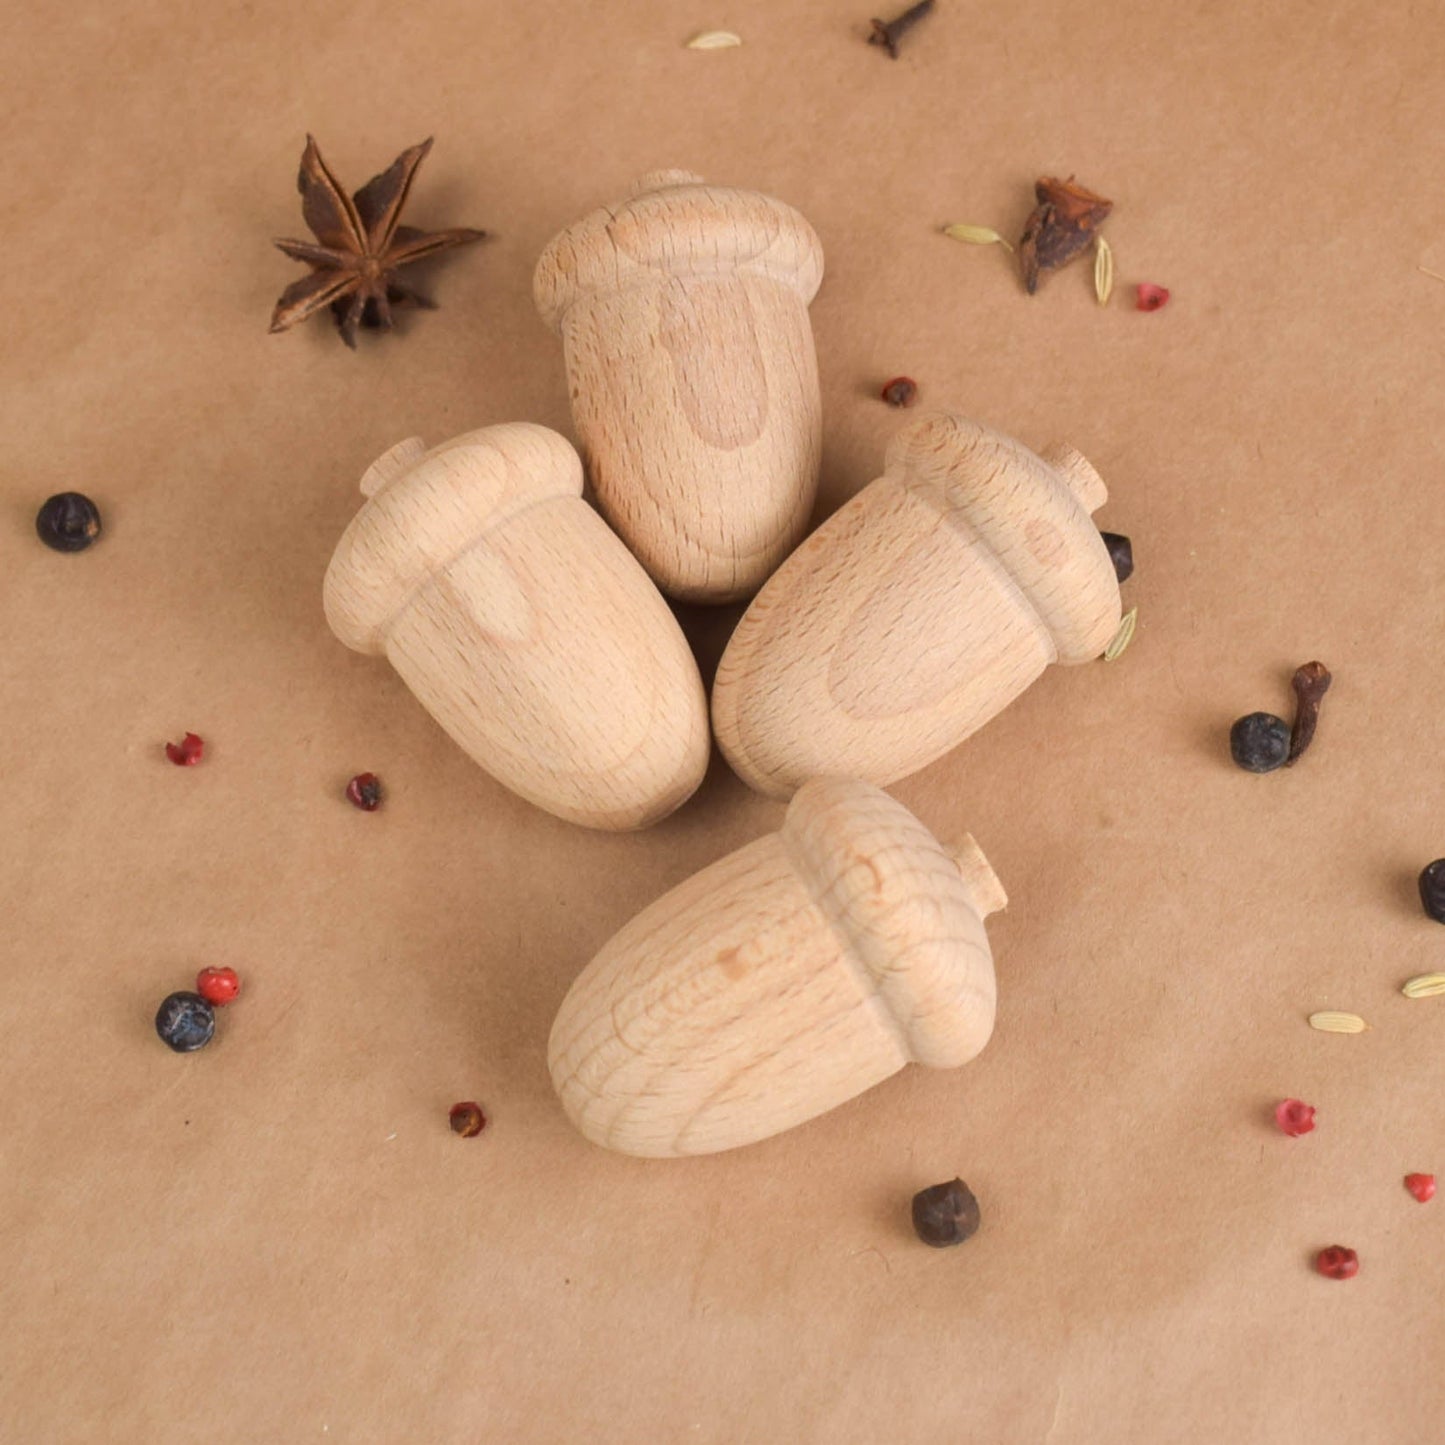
(712, 412), (1120, 798)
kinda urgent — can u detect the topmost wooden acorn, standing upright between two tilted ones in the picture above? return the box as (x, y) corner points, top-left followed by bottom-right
(533, 171), (822, 603)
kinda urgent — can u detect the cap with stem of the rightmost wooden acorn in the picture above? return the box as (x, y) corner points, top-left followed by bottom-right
(886, 412), (1121, 662)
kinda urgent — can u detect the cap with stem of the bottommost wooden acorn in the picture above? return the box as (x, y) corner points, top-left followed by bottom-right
(780, 777), (1007, 1068)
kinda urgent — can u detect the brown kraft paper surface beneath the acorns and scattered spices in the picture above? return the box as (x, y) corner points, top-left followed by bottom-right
(0, 0), (1445, 1445)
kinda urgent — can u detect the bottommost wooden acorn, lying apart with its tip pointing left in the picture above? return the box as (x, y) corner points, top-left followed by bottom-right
(548, 779), (1007, 1156)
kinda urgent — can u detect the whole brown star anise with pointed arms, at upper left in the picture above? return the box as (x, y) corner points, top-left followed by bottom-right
(270, 136), (487, 347)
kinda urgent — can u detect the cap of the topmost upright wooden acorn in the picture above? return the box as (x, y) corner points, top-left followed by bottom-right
(532, 171), (822, 331)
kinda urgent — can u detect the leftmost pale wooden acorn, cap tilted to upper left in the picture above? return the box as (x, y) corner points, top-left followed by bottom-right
(325, 422), (709, 828)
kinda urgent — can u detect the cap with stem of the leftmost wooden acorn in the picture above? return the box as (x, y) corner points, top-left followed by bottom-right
(322, 422), (582, 653)
